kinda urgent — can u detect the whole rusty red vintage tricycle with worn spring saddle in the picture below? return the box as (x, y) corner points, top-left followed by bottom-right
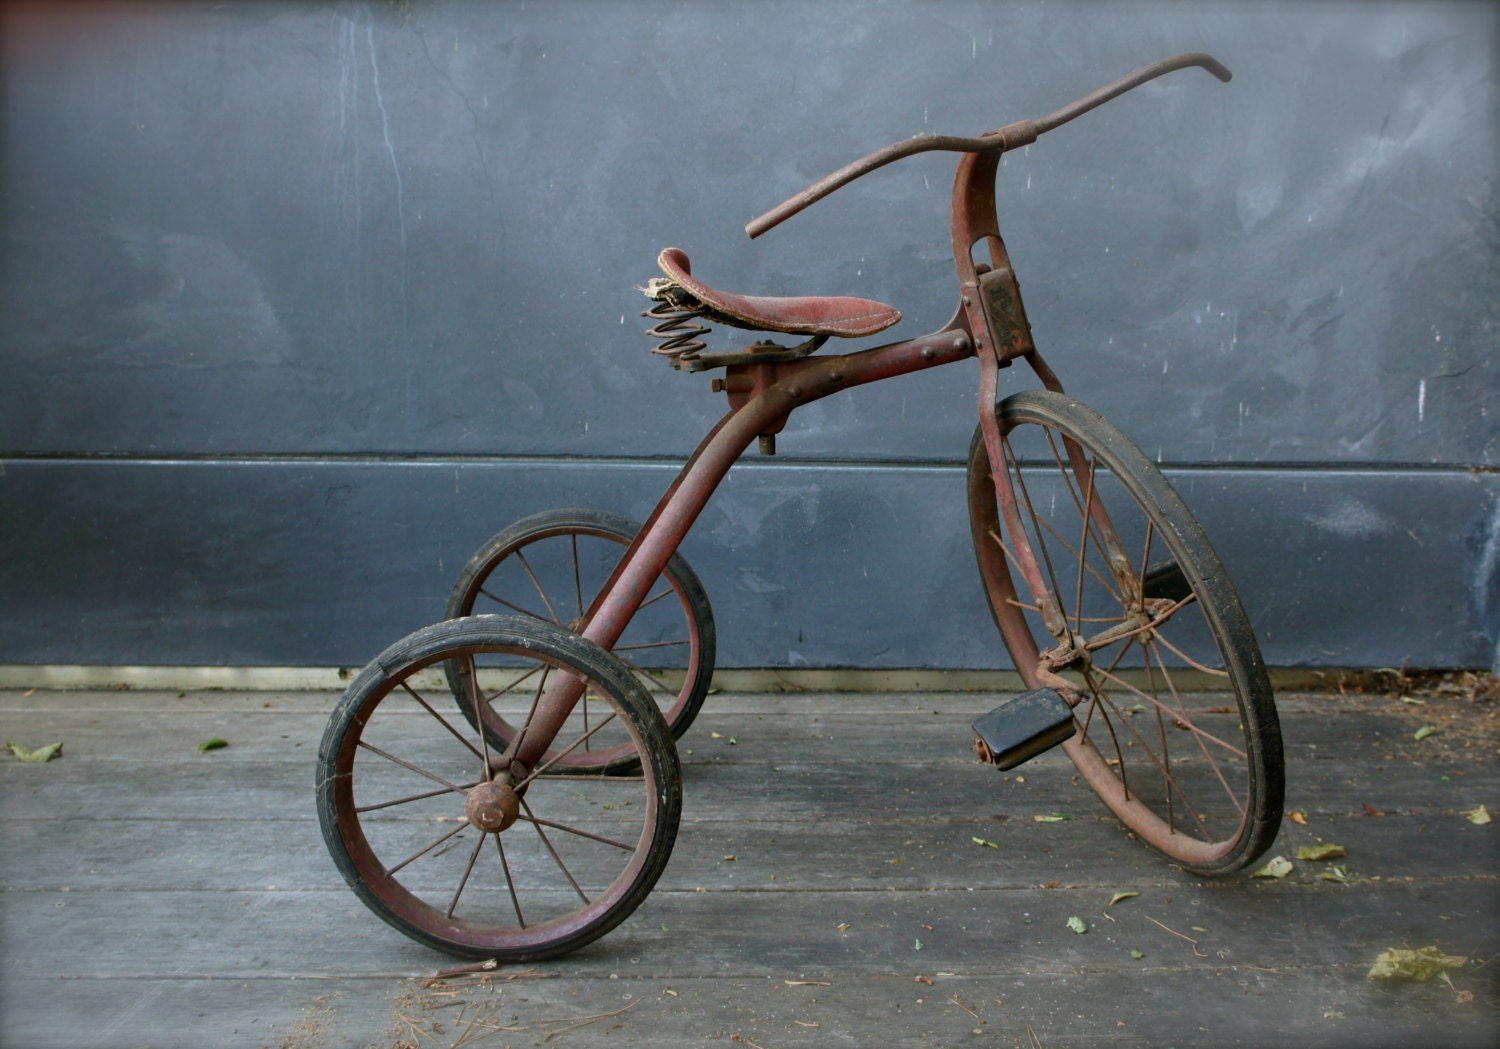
(317, 54), (1284, 960)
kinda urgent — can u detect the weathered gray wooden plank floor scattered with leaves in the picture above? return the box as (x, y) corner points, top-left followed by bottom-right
(0, 692), (1500, 1049)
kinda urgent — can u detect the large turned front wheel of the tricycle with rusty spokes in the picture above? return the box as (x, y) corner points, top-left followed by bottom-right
(968, 390), (1284, 873)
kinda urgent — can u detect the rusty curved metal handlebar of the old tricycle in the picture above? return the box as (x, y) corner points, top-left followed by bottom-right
(746, 51), (1232, 239)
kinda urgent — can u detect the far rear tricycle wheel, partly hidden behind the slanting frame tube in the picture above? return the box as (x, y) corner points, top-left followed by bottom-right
(444, 507), (717, 773)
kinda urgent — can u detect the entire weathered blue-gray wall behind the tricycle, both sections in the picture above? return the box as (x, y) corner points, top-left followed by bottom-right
(0, 0), (1500, 668)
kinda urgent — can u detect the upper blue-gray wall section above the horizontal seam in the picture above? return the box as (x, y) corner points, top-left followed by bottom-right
(0, 2), (1500, 464)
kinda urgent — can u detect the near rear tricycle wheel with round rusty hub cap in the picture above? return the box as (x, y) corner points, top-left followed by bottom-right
(325, 615), (683, 962)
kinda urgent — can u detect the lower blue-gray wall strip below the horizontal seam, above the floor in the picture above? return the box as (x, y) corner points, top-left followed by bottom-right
(0, 461), (1500, 668)
